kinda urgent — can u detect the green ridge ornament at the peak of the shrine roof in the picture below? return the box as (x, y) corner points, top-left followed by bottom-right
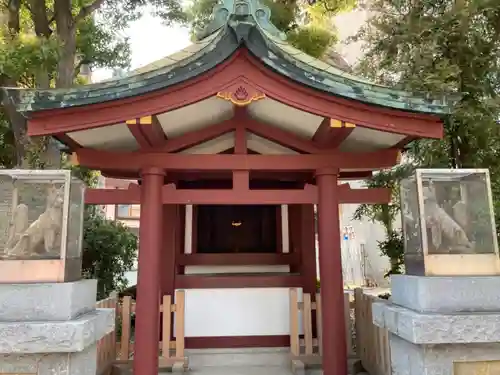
(196, 0), (286, 40)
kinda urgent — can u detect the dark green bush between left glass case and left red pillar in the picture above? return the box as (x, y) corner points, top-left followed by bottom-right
(82, 206), (137, 299)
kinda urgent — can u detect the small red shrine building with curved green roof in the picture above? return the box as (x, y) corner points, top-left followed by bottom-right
(1, 0), (448, 375)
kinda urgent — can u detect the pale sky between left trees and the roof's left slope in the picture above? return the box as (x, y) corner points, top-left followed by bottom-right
(92, 13), (190, 82)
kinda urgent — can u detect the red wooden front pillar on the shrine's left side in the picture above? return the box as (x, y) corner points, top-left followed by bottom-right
(134, 168), (165, 375)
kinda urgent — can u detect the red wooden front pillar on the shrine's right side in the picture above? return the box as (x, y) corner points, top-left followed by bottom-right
(316, 169), (347, 375)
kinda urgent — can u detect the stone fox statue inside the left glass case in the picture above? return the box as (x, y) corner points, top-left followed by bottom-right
(6, 186), (64, 257)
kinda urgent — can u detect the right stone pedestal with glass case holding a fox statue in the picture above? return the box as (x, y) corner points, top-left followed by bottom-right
(372, 169), (500, 375)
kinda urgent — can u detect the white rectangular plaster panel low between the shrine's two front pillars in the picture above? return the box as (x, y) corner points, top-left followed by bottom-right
(180, 288), (302, 337)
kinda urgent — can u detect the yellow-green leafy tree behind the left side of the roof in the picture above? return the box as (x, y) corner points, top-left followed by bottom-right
(0, 0), (184, 167)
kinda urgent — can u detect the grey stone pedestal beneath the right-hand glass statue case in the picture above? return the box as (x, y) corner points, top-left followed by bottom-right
(372, 275), (500, 375)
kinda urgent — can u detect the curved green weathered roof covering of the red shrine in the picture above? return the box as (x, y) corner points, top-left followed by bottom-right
(3, 0), (456, 114)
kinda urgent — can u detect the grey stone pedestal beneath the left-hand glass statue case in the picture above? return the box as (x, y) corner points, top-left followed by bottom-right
(0, 280), (115, 375)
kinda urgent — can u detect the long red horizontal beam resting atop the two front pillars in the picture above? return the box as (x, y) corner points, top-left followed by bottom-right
(76, 149), (399, 171)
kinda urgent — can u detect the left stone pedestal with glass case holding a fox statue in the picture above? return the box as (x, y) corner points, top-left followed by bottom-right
(0, 170), (115, 375)
